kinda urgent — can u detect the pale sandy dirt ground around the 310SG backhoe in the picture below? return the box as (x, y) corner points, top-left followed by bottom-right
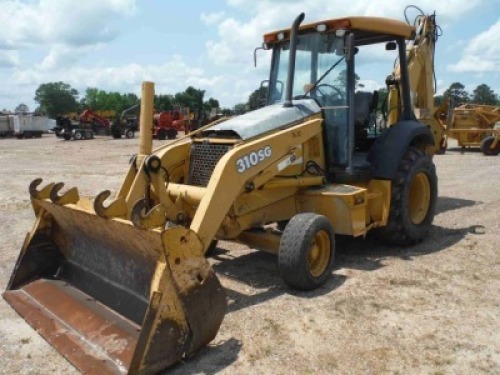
(0, 135), (500, 375)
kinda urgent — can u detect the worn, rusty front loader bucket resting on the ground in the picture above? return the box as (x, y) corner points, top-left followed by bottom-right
(3, 199), (226, 374)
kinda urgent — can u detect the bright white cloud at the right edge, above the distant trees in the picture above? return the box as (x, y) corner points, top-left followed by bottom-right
(448, 19), (500, 73)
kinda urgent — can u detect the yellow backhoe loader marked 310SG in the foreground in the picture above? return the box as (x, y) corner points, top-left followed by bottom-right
(3, 6), (442, 374)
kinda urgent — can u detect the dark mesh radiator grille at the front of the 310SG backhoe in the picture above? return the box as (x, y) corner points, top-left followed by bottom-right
(189, 143), (232, 186)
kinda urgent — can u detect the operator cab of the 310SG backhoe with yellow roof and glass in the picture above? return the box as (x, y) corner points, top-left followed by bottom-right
(264, 17), (412, 182)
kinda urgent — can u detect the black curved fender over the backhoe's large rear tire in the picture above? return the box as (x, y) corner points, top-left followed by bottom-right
(368, 120), (434, 180)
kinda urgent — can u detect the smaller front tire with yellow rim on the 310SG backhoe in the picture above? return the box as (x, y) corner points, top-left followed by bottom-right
(278, 213), (335, 290)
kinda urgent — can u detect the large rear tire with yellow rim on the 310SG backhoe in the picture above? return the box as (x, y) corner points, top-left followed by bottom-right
(375, 147), (438, 246)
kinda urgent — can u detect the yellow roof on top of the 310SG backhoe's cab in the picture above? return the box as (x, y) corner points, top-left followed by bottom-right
(264, 16), (415, 43)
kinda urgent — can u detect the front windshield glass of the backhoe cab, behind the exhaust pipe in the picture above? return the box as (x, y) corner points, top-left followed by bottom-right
(268, 33), (347, 107)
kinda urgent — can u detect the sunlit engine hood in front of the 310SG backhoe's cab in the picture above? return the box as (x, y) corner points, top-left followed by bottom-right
(201, 99), (321, 140)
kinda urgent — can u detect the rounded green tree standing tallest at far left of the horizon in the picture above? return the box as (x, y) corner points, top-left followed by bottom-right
(35, 82), (78, 117)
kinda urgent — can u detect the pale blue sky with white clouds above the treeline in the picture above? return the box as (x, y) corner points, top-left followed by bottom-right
(0, 0), (500, 110)
